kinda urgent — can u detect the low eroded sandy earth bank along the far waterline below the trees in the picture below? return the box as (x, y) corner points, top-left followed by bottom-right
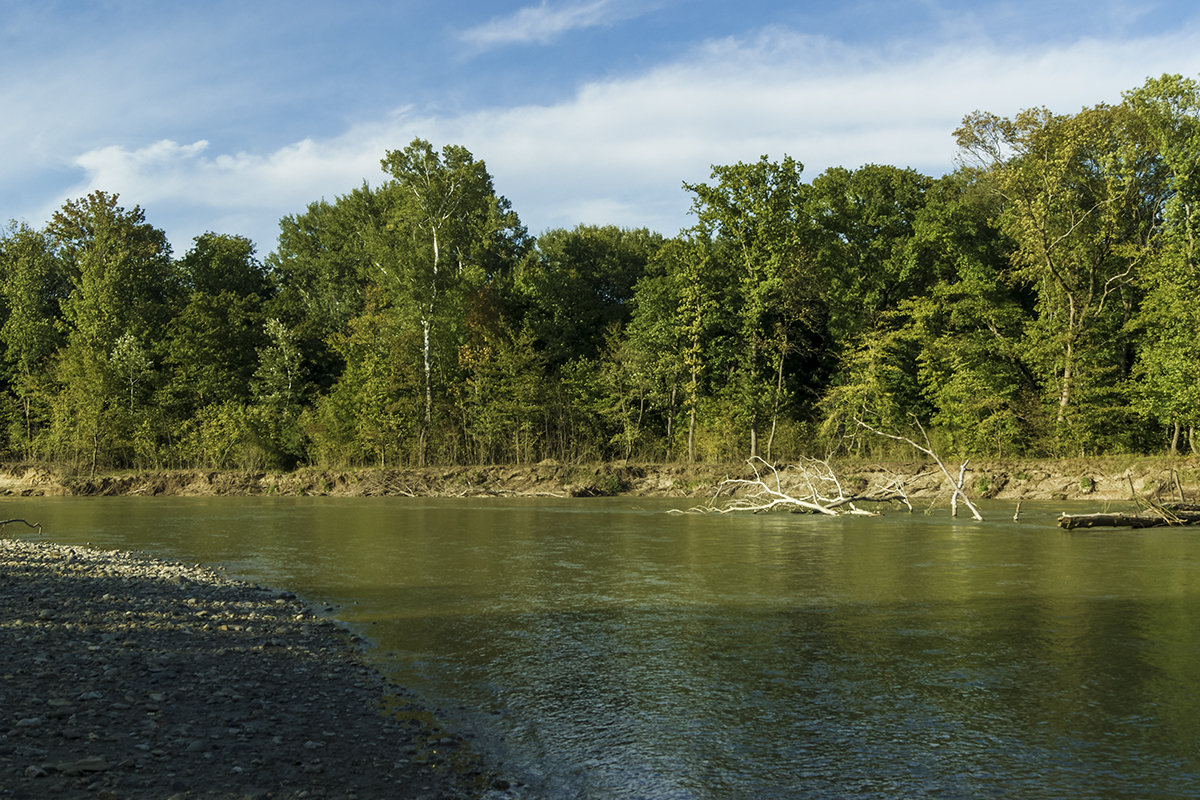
(0, 456), (1200, 500)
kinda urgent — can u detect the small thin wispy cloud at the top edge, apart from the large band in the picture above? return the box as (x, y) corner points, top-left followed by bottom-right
(460, 0), (649, 49)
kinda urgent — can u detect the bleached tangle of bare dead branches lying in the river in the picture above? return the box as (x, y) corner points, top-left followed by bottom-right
(692, 456), (912, 517)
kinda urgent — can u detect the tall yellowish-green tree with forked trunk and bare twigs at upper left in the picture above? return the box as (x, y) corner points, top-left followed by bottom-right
(956, 106), (1162, 450)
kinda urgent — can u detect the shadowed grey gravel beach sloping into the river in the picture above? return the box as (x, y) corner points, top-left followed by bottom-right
(0, 539), (514, 800)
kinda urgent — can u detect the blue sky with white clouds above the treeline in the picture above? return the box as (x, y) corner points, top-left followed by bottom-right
(7, 0), (1200, 255)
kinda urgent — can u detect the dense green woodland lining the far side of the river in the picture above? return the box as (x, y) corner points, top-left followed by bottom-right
(0, 76), (1200, 470)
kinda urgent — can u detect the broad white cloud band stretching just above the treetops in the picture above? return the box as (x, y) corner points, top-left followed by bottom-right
(56, 26), (1200, 251)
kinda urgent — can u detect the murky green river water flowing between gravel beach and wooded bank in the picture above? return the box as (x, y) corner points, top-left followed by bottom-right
(9, 498), (1200, 800)
